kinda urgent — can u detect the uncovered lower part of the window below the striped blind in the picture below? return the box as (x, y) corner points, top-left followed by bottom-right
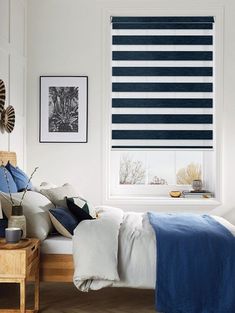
(110, 150), (214, 196)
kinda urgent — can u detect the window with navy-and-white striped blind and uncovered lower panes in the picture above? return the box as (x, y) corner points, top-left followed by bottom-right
(110, 16), (214, 196)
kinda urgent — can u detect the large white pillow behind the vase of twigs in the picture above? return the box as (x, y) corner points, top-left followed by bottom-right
(0, 191), (54, 240)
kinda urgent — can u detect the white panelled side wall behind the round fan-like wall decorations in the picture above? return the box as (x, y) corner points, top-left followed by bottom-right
(0, 0), (27, 168)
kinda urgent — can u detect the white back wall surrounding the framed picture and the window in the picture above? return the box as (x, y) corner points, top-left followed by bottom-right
(27, 0), (235, 212)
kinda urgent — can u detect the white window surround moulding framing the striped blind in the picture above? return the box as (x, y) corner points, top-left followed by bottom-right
(102, 2), (224, 208)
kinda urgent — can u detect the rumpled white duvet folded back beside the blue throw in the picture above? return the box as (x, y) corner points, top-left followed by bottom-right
(73, 207), (235, 291)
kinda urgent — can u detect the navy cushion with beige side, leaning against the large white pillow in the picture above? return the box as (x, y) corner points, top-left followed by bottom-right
(49, 208), (78, 238)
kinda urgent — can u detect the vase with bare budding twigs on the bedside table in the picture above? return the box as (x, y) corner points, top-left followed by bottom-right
(0, 167), (38, 238)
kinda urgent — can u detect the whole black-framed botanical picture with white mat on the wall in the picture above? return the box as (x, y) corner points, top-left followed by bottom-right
(39, 76), (88, 142)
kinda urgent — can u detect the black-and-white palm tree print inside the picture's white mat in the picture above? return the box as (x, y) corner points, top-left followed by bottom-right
(48, 86), (79, 133)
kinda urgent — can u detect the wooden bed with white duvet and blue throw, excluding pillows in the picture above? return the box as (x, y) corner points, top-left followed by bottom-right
(0, 152), (235, 313)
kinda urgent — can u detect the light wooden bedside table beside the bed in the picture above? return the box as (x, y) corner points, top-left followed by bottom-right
(0, 239), (40, 313)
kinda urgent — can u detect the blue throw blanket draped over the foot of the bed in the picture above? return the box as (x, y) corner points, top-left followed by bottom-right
(148, 213), (235, 313)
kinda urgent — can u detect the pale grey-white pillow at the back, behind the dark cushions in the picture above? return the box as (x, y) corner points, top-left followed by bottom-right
(40, 184), (78, 208)
